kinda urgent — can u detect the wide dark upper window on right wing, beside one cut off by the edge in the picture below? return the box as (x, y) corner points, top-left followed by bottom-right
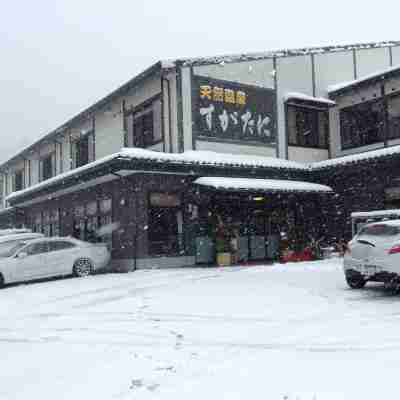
(340, 99), (384, 150)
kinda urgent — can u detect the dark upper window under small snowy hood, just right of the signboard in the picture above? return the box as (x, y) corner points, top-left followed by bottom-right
(286, 104), (329, 149)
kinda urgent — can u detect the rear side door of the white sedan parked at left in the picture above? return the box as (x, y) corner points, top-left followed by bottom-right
(49, 240), (78, 275)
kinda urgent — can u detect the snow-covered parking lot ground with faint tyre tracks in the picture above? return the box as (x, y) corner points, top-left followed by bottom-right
(0, 259), (400, 400)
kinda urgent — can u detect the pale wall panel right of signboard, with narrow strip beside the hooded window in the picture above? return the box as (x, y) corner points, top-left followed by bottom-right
(276, 55), (313, 158)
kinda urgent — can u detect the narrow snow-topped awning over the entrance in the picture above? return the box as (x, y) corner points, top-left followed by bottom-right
(194, 177), (333, 193)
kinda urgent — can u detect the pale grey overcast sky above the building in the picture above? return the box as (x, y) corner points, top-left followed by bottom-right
(0, 0), (400, 162)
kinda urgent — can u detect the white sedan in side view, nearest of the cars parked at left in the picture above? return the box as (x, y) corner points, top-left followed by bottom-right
(0, 237), (110, 285)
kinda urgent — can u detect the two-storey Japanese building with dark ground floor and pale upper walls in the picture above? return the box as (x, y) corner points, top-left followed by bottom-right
(0, 42), (400, 269)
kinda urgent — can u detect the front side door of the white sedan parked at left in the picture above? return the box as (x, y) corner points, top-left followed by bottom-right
(15, 241), (48, 281)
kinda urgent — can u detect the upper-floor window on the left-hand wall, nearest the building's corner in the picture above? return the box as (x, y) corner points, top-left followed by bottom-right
(125, 100), (162, 148)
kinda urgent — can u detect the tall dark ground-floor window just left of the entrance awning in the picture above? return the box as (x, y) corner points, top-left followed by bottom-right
(148, 193), (183, 255)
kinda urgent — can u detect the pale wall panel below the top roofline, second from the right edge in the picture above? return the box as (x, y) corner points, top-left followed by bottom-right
(356, 47), (390, 78)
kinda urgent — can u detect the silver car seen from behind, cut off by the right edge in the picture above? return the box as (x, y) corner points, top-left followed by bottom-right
(344, 220), (400, 289)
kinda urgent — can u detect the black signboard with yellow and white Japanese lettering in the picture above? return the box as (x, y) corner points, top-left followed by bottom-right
(192, 76), (276, 145)
